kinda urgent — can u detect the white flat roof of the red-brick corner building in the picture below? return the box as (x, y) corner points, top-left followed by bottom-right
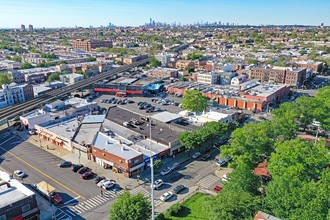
(93, 132), (142, 160)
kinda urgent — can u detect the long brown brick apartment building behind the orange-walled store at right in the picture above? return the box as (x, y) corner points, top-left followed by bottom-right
(249, 67), (306, 87)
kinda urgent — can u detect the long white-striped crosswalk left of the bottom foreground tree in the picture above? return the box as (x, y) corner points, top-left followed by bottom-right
(68, 190), (124, 214)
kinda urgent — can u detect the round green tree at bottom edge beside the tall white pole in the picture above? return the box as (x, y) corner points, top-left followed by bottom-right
(110, 191), (151, 220)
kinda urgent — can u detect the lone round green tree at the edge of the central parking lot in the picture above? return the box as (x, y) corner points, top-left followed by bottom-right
(182, 90), (207, 112)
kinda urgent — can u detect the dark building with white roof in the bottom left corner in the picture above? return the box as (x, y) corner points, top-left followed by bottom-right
(0, 170), (40, 220)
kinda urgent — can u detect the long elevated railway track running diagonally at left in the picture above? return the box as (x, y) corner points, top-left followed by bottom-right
(0, 58), (150, 126)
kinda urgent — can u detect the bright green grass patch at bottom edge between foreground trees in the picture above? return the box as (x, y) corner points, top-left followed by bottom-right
(165, 193), (209, 220)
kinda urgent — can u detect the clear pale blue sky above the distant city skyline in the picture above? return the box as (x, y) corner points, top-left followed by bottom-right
(0, 0), (330, 28)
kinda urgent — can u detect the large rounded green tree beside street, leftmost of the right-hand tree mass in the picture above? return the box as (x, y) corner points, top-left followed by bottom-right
(221, 121), (276, 167)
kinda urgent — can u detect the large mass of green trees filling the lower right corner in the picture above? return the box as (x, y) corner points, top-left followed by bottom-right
(205, 87), (330, 220)
